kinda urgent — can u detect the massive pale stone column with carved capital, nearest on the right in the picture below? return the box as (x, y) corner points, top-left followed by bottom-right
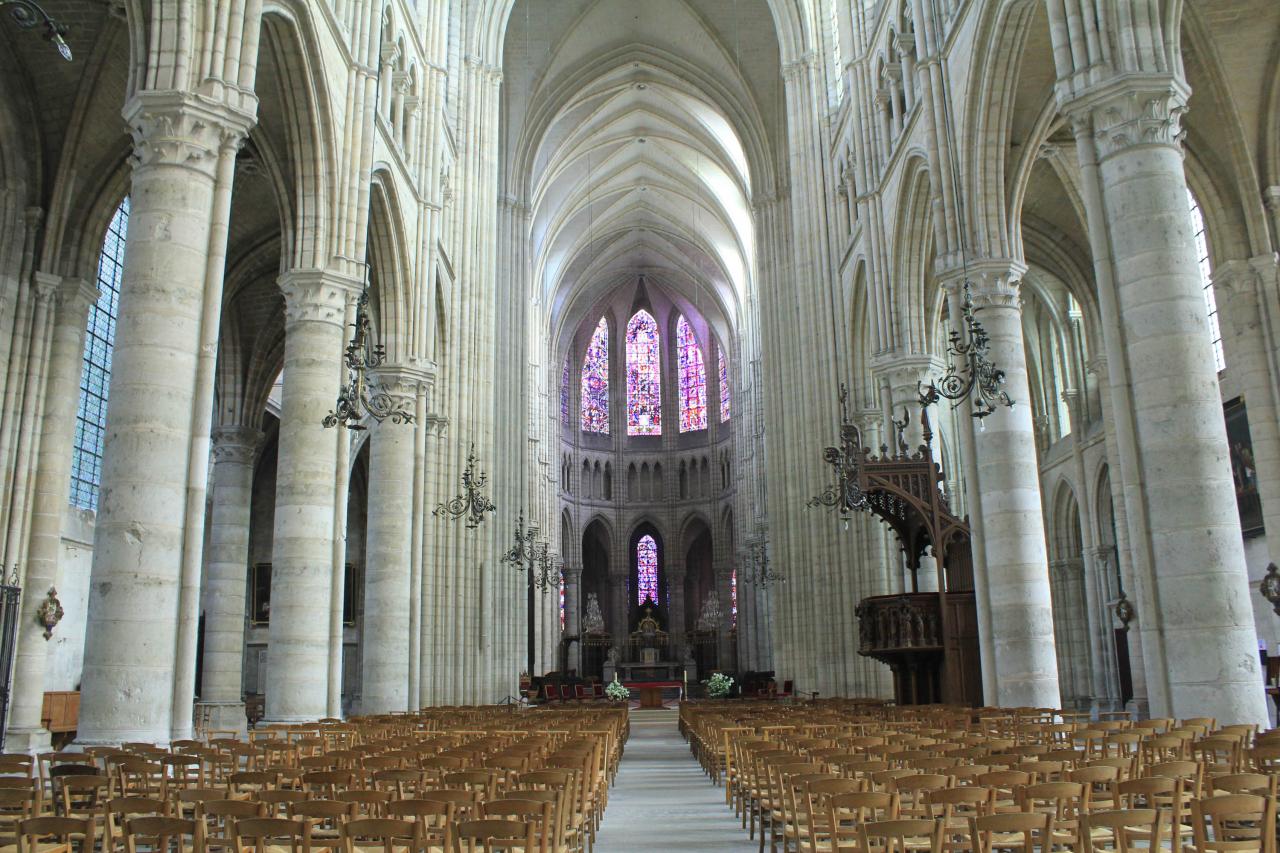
(1055, 81), (1267, 724)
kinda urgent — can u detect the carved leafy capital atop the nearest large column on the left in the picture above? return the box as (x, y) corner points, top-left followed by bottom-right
(124, 91), (255, 177)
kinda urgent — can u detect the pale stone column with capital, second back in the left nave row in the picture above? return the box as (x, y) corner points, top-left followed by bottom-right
(266, 269), (358, 722)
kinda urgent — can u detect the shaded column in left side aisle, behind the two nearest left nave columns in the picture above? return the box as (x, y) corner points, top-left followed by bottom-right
(200, 427), (262, 731)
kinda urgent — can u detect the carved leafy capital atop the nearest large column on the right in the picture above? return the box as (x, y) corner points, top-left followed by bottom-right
(1064, 74), (1190, 160)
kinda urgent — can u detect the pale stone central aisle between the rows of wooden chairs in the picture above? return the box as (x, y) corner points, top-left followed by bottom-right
(595, 711), (756, 853)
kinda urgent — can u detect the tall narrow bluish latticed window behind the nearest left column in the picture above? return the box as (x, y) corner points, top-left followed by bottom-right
(70, 197), (129, 510)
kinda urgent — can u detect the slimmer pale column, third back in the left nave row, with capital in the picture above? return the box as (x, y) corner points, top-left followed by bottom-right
(360, 368), (425, 713)
